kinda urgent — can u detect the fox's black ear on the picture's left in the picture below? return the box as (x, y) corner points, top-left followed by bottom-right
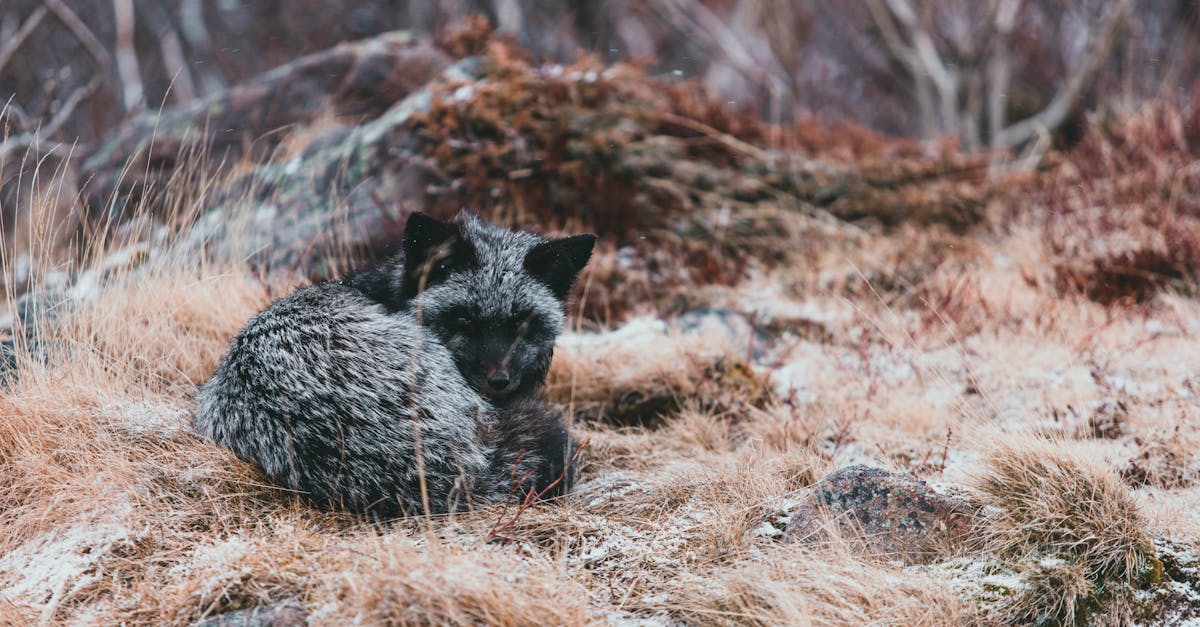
(401, 213), (475, 301)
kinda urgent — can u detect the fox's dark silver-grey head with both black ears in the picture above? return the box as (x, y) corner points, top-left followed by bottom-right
(401, 213), (596, 405)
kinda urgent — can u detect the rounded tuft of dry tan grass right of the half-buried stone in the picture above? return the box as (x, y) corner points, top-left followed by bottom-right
(978, 436), (1163, 625)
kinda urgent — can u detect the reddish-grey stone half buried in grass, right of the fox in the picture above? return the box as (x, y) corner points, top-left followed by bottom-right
(782, 466), (979, 563)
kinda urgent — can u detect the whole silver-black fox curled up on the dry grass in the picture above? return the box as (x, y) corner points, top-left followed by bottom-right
(194, 213), (595, 516)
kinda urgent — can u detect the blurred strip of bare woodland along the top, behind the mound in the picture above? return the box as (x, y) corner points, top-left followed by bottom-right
(0, 0), (1200, 147)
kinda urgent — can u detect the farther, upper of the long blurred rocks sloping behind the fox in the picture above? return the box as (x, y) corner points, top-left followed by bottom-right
(82, 31), (450, 222)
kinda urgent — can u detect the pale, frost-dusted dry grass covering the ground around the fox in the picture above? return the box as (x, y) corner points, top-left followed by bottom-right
(0, 101), (1200, 625)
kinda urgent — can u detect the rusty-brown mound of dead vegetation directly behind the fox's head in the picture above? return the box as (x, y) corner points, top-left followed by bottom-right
(407, 22), (1000, 322)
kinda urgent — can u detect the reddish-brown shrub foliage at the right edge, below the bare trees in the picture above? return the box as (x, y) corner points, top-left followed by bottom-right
(1025, 103), (1200, 305)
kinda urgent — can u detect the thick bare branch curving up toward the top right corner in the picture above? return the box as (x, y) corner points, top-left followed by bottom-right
(992, 0), (1133, 148)
